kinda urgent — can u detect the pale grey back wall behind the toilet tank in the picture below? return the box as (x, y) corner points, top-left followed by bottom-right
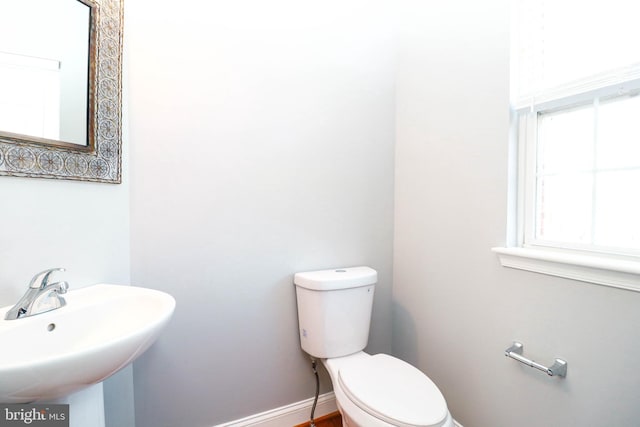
(125, 0), (395, 427)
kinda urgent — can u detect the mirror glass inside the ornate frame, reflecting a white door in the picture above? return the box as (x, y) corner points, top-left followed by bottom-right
(0, 0), (91, 146)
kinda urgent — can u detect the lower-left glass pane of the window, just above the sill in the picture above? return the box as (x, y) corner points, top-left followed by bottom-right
(536, 173), (593, 244)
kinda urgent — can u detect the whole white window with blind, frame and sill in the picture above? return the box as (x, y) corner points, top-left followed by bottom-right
(495, 0), (640, 291)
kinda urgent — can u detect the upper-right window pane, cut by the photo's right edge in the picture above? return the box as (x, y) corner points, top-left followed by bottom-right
(598, 96), (640, 171)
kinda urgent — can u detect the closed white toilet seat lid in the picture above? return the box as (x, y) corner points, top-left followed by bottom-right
(338, 354), (449, 427)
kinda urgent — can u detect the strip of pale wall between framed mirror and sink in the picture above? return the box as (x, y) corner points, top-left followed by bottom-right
(0, 176), (129, 298)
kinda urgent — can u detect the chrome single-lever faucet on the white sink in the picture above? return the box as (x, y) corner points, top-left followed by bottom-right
(4, 268), (69, 320)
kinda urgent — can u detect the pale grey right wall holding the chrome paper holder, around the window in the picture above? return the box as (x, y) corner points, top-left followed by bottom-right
(393, 0), (640, 427)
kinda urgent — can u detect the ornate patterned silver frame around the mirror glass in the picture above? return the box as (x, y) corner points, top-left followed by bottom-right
(0, 0), (123, 184)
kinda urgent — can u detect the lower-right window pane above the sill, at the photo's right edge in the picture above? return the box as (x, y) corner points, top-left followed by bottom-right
(594, 170), (640, 249)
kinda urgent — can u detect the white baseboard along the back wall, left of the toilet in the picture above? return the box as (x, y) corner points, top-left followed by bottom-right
(213, 391), (338, 427)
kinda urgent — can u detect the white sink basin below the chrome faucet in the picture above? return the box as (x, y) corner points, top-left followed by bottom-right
(0, 284), (175, 403)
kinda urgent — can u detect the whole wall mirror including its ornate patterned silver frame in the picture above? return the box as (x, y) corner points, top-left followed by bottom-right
(0, 0), (122, 183)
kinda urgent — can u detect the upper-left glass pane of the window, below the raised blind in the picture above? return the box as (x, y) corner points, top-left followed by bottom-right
(538, 105), (594, 174)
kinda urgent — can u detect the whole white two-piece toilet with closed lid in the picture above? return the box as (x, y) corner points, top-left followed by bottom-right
(293, 267), (454, 427)
